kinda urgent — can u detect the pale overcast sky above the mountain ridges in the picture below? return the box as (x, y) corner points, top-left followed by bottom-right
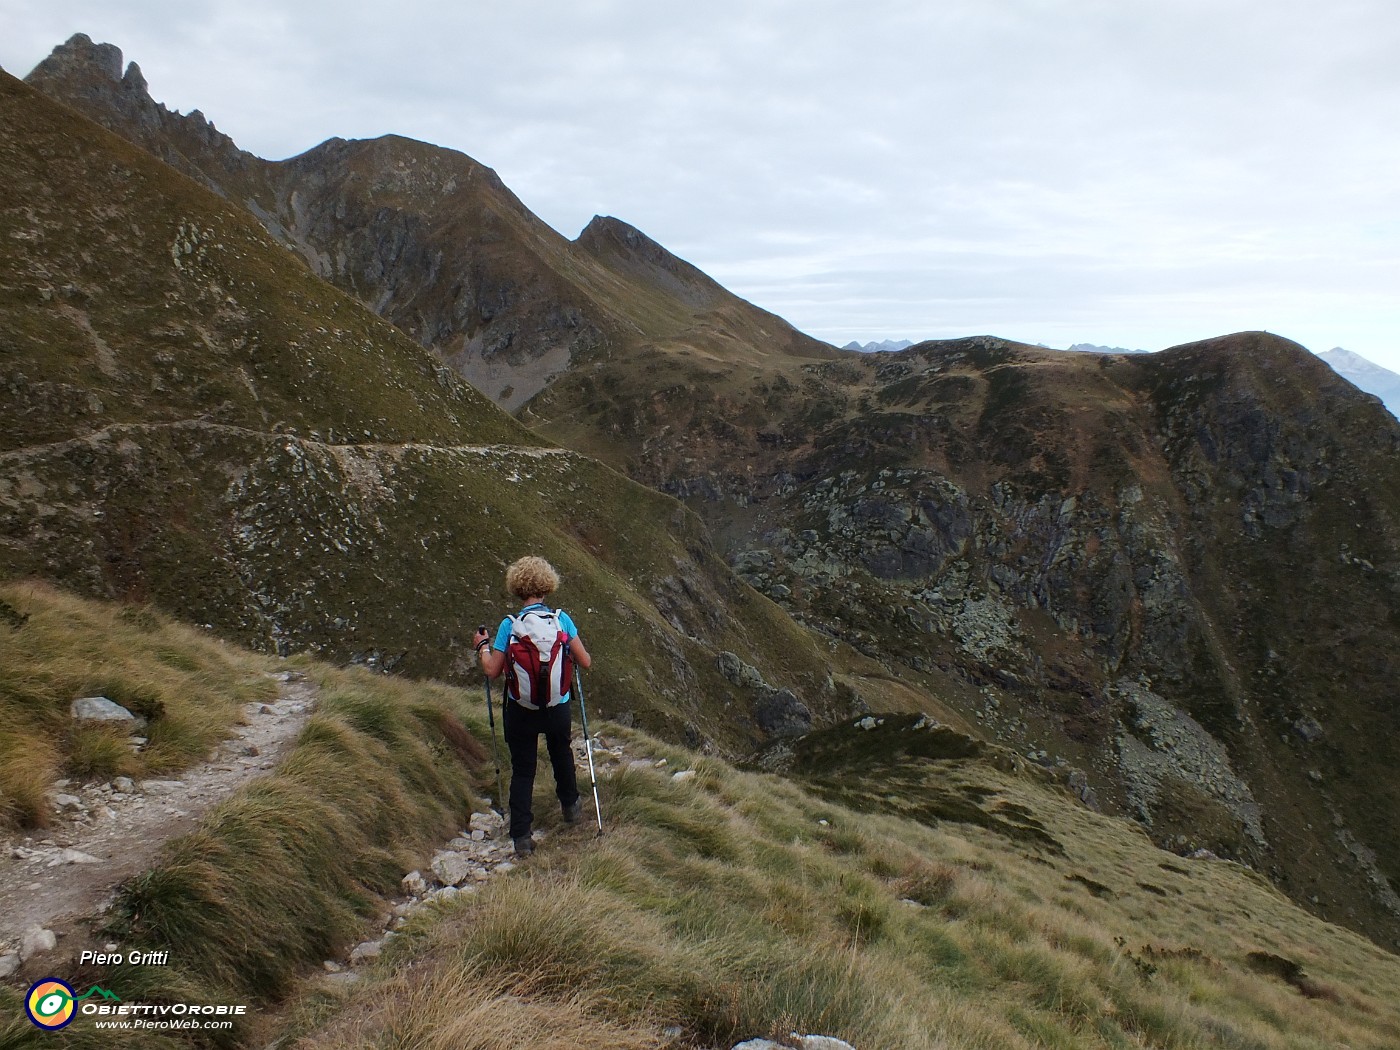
(0, 0), (1400, 371)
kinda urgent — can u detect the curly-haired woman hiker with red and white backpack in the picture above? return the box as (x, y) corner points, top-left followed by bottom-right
(472, 556), (592, 857)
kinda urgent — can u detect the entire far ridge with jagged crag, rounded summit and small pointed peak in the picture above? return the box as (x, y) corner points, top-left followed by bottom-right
(27, 34), (830, 410)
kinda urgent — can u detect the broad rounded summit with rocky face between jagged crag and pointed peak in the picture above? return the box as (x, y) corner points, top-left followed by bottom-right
(267, 136), (605, 407)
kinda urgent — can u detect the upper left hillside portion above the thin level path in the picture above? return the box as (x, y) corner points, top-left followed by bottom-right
(0, 76), (538, 448)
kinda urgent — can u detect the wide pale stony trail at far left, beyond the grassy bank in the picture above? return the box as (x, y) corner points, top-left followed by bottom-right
(0, 671), (316, 976)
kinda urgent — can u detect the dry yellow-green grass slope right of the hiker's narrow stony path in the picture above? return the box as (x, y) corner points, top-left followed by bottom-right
(281, 738), (1400, 1050)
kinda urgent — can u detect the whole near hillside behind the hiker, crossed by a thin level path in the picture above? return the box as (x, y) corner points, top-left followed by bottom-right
(0, 67), (855, 750)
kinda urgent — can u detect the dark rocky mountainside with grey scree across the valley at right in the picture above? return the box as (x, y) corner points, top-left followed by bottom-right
(531, 324), (1400, 944)
